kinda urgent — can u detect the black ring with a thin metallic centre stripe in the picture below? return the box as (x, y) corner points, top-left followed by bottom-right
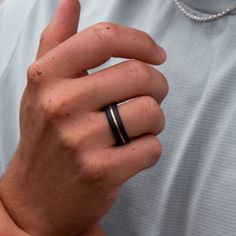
(104, 103), (130, 146)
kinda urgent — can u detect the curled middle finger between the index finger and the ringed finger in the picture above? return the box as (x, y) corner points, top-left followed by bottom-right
(68, 60), (168, 111)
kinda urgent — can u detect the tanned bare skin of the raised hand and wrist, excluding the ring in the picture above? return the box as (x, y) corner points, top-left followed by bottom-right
(0, 0), (168, 236)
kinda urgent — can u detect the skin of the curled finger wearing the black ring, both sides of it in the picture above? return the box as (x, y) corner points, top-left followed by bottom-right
(95, 96), (165, 147)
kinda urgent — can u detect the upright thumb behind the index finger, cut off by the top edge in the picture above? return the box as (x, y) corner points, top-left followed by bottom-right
(37, 0), (80, 59)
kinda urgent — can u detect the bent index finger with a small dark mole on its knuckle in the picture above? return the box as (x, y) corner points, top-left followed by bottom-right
(36, 22), (166, 77)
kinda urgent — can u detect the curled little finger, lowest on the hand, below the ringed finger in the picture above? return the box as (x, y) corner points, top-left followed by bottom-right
(104, 134), (162, 185)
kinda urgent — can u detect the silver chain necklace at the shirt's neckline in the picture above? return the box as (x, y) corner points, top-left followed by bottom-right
(174, 0), (236, 23)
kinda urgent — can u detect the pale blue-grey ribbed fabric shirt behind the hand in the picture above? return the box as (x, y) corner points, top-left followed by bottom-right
(0, 0), (236, 236)
